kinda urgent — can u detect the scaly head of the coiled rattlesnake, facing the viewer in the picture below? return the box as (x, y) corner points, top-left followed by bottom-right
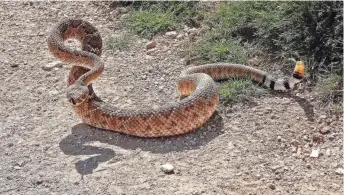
(67, 80), (89, 106)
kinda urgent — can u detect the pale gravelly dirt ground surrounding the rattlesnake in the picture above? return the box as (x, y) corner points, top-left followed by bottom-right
(0, 1), (343, 195)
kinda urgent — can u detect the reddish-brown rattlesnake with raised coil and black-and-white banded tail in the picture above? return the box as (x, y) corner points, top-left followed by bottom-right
(47, 19), (304, 137)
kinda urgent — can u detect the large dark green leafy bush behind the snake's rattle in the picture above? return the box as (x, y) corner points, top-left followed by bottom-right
(203, 1), (343, 81)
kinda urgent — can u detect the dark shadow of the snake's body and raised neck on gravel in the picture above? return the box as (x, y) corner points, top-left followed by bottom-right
(59, 111), (224, 176)
